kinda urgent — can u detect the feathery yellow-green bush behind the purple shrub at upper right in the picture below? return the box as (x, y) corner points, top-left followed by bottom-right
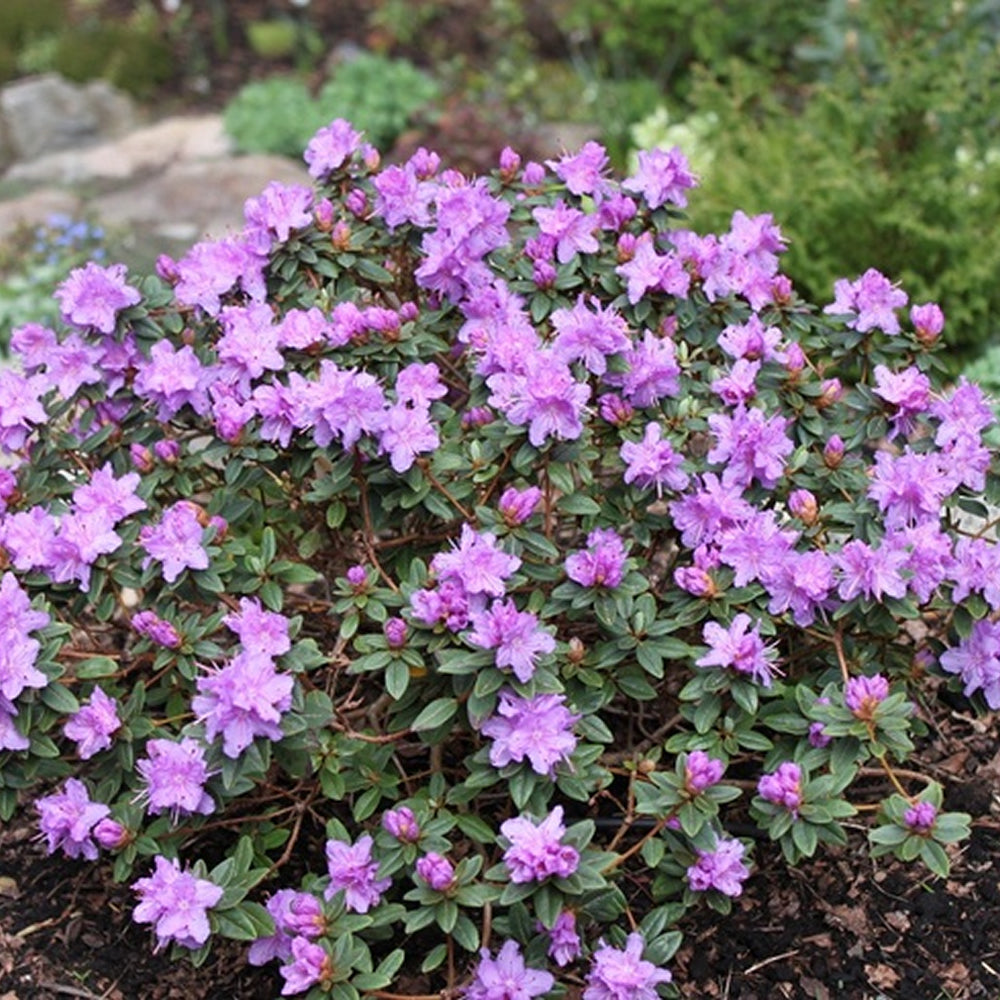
(668, 0), (1000, 364)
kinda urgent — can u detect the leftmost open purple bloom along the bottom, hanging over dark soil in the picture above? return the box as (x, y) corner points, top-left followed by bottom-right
(132, 855), (222, 948)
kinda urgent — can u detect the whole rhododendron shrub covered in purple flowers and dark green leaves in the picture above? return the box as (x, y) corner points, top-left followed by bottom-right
(0, 121), (988, 1000)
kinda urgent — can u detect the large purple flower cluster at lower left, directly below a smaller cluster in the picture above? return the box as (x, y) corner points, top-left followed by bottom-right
(191, 648), (295, 759)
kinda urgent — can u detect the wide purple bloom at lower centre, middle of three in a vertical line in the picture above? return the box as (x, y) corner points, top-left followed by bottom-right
(482, 690), (580, 777)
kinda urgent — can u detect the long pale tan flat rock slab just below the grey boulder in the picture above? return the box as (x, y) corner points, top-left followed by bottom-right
(5, 115), (231, 184)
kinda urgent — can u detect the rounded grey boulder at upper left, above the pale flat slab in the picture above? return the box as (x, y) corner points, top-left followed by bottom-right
(0, 73), (135, 160)
